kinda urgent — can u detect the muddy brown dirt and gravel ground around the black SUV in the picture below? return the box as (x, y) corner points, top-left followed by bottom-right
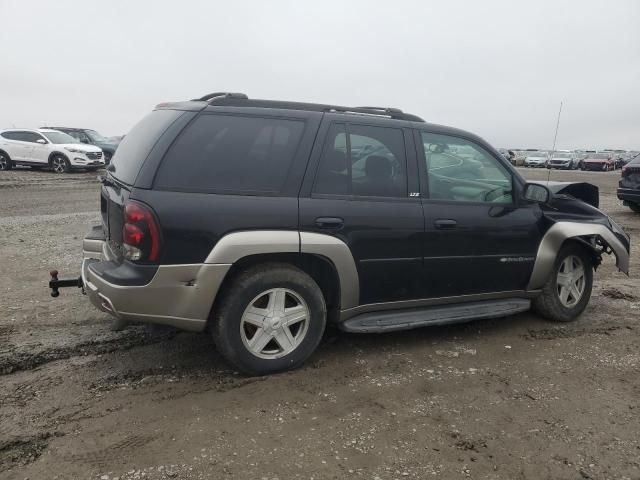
(0, 169), (640, 480)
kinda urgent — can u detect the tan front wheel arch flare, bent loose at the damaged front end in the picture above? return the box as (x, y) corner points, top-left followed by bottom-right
(527, 222), (629, 290)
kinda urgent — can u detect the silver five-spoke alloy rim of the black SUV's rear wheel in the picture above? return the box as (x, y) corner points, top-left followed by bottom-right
(240, 288), (311, 359)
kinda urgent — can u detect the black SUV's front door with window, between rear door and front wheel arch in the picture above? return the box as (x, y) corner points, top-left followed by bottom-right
(415, 131), (542, 298)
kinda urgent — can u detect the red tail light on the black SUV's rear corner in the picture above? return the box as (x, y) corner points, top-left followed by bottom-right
(122, 200), (161, 262)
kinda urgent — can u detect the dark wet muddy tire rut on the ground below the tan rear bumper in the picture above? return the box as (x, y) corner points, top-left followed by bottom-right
(0, 326), (179, 375)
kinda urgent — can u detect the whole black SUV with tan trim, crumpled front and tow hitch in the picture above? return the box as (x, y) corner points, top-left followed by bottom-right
(50, 93), (629, 374)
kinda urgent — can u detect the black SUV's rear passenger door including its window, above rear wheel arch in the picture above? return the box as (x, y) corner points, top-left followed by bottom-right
(300, 118), (424, 304)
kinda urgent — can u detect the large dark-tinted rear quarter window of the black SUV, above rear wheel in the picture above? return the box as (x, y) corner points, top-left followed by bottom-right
(154, 115), (304, 193)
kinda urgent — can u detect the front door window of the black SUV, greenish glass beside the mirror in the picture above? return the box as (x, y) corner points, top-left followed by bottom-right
(421, 132), (513, 203)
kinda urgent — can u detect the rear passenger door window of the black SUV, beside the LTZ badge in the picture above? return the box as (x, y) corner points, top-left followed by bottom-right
(313, 123), (407, 197)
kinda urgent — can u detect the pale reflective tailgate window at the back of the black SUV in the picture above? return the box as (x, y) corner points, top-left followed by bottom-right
(109, 110), (184, 185)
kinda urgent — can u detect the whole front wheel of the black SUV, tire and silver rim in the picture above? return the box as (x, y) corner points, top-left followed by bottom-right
(533, 244), (593, 322)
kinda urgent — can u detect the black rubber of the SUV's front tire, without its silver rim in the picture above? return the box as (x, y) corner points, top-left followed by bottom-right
(532, 243), (593, 322)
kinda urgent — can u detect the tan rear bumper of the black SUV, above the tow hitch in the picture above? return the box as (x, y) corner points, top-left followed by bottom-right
(82, 230), (231, 331)
